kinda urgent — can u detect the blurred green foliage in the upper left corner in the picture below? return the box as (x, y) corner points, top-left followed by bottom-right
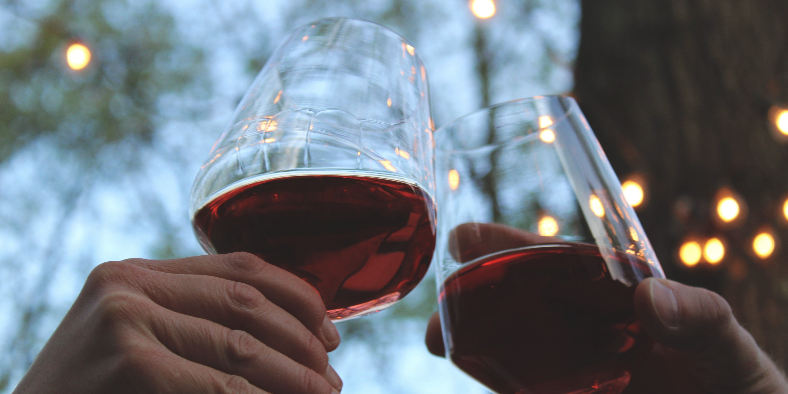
(0, 0), (208, 165)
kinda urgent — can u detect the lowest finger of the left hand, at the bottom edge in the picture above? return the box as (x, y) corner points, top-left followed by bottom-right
(119, 344), (269, 394)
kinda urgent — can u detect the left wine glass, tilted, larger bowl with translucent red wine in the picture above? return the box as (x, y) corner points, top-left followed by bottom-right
(190, 18), (435, 320)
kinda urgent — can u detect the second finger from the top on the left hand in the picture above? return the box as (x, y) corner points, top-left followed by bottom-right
(121, 267), (328, 374)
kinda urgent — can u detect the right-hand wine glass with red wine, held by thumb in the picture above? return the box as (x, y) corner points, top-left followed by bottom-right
(435, 96), (664, 394)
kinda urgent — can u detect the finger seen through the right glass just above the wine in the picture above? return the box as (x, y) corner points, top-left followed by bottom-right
(449, 223), (563, 262)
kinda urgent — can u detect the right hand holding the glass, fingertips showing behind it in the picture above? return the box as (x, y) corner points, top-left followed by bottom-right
(426, 223), (788, 394)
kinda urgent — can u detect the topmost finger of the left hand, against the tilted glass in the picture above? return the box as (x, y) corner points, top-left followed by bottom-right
(129, 253), (340, 351)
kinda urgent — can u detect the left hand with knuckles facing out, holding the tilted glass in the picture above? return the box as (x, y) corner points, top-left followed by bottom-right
(14, 253), (342, 394)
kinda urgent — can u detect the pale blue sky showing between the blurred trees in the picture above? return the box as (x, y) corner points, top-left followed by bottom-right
(0, 0), (580, 394)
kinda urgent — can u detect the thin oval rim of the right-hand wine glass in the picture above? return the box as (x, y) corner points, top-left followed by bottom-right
(434, 94), (575, 153)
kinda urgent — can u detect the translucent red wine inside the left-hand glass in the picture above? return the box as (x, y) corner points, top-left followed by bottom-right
(193, 174), (435, 319)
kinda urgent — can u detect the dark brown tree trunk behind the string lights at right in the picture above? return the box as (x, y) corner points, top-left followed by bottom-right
(575, 0), (788, 366)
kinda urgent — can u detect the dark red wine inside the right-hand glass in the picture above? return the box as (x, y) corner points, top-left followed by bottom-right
(439, 244), (653, 394)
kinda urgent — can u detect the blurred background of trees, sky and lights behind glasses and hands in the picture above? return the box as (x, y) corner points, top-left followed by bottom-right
(0, 0), (788, 394)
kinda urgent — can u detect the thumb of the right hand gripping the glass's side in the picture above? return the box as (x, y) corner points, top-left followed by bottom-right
(635, 278), (788, 393)
